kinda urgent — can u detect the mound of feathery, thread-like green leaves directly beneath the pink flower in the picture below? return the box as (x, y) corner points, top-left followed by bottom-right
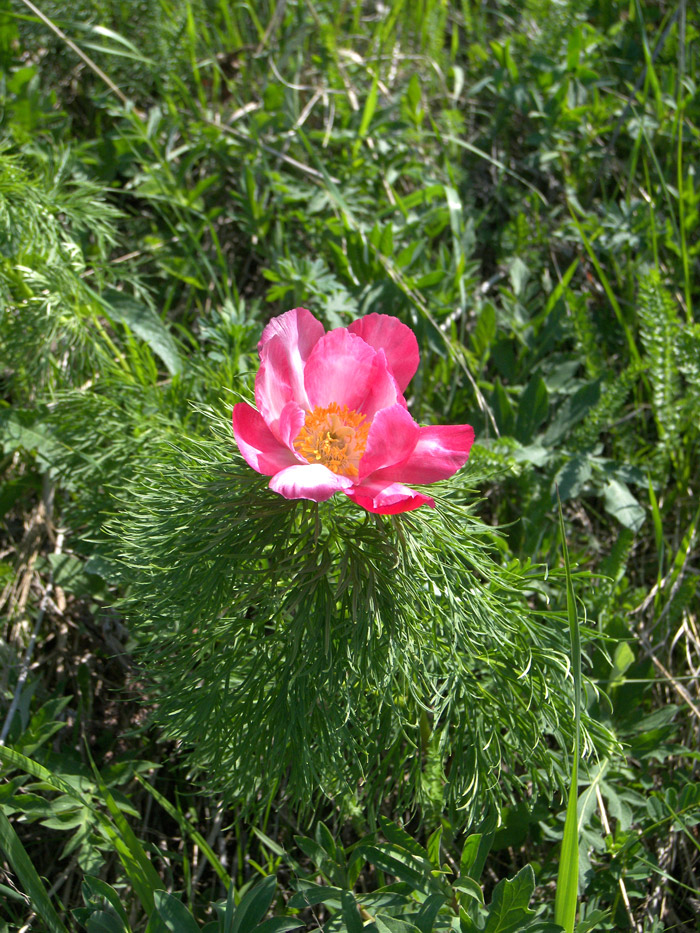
(100, 408), (609, 823)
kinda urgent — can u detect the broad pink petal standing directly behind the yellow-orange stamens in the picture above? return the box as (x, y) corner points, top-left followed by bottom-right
(304, 327), (405, 419)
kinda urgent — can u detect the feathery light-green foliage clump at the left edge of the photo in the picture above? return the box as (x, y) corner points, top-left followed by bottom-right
(0, 151), (145, 401)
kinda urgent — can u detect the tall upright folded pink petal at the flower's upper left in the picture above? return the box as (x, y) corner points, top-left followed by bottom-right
(255, 308), (324, 431)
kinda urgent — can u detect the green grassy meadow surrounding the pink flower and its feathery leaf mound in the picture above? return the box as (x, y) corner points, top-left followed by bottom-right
(0, 0), (700, 933)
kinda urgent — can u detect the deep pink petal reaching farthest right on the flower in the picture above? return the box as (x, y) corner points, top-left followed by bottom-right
(361, 424), (474, 484)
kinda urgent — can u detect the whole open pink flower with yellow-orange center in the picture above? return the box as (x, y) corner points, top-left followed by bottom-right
(233, 308), (474, 515)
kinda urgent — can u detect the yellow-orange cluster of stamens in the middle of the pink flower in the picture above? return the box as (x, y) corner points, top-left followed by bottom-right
(294, 402), (369, 476)
